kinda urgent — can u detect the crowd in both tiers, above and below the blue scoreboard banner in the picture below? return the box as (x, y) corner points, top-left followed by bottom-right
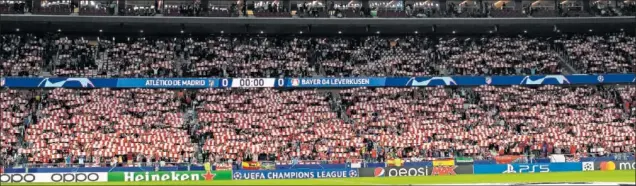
(0, 34), (636, 166)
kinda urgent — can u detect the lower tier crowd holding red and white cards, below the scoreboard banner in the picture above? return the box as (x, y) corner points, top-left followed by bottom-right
(0, 85), (636, 165)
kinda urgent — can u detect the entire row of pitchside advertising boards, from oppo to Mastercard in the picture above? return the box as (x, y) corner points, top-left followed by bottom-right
(0, 160), (636, 183)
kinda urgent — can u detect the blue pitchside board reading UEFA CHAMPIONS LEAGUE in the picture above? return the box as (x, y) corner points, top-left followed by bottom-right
(232, 169), (360, 180)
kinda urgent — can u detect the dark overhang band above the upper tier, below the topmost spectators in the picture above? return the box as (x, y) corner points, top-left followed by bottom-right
(0, 15), (636, 36)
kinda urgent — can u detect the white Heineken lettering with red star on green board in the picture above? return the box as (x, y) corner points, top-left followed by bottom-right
(124, 171), (216, 182)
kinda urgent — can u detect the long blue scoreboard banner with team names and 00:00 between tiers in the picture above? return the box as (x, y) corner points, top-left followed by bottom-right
(0, 74), (636, 88)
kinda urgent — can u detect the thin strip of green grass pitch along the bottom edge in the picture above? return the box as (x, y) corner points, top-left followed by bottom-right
(3, 170), (636, 185)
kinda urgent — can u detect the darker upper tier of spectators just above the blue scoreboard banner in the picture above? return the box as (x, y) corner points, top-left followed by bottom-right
(0, 33), (636, 77)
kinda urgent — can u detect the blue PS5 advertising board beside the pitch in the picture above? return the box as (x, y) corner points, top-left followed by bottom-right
(474, 162), (583, 174)
